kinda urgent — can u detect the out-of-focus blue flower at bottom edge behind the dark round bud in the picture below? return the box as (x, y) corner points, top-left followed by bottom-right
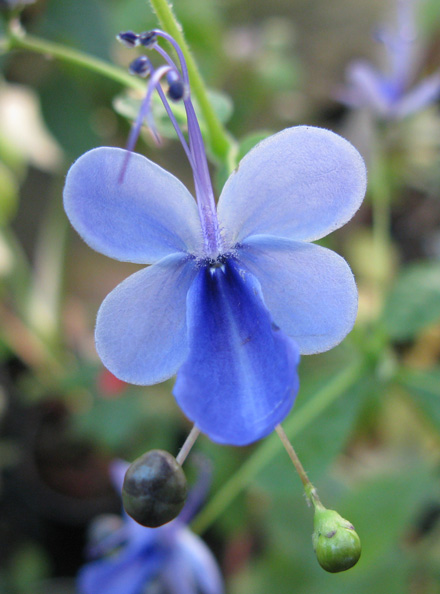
(77, 461), (223, 594)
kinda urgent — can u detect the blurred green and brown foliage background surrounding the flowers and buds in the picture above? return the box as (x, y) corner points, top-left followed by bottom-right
(0, 0), (440, 594)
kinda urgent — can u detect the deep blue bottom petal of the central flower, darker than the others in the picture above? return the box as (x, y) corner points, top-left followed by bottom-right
(174, 260), (299, 445)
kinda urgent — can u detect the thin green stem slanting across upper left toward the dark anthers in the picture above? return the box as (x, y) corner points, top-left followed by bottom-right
(3, 24), (145, 92)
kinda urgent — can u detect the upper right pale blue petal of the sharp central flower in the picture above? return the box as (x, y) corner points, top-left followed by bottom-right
(218, 126), (366, 248)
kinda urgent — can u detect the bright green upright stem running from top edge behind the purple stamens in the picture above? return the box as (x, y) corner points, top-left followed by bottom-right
(150, 0), (232, 163)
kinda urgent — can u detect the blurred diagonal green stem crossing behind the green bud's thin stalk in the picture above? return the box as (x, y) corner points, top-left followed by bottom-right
(191, 361), (366, 533)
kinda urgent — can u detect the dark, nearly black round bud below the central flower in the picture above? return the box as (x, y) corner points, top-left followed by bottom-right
(122, 450), (187, 528)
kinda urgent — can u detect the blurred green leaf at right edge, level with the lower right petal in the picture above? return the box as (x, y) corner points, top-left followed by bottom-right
(383, 262), (440, 340)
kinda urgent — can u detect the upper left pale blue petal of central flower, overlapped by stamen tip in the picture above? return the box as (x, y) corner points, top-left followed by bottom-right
(64, 147), (203, 264)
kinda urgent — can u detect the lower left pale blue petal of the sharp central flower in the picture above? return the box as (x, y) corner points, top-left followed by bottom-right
(95, 254), (197, 385)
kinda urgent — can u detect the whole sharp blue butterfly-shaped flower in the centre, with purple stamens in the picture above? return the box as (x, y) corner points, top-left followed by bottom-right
(64, 32), (366, 445)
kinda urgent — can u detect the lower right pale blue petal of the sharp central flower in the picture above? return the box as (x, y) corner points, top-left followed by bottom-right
(238, 236), (357, 355)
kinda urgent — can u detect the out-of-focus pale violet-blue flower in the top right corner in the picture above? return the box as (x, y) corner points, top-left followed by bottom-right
(337, 0), (440, 119)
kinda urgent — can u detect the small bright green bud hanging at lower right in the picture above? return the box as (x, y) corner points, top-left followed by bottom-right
(312, 506), (361, 573)
